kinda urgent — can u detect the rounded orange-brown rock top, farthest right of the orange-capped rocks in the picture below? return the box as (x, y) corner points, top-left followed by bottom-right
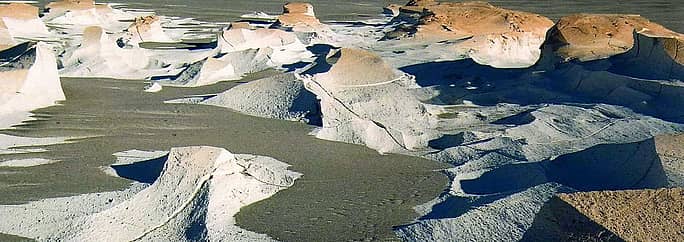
(549, 14), (683, 64)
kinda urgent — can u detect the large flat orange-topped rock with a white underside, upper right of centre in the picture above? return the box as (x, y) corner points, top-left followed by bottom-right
(386, 1), (553, 68)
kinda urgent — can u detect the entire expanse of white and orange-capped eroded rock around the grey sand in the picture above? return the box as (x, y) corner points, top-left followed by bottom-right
(0, 0), (684, 241)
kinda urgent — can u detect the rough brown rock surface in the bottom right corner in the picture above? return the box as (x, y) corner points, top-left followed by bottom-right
(559, 188), (684, 241)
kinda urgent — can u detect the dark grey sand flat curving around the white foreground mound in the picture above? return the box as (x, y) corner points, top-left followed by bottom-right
(0, 73), (448, 241)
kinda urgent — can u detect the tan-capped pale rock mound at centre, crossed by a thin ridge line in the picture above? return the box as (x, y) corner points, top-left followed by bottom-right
(302, 48), (434, 153)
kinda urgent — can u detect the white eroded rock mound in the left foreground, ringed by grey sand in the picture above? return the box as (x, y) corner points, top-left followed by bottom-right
(0, 147), (301, 241)
